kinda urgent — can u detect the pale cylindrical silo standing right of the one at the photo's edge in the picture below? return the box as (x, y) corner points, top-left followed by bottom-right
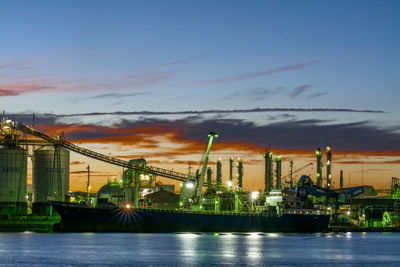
(32, 147), (69, 203)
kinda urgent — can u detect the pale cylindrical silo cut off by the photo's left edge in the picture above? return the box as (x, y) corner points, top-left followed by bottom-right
(0, 147), (27, 215)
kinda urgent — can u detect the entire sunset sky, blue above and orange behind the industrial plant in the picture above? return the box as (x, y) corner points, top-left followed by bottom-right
(0, 0), (400, 193)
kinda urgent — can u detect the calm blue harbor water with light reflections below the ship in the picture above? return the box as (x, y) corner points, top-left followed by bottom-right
(0, 232), (400, 266)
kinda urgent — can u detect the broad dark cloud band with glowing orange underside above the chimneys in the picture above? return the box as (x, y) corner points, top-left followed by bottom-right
(10, 117), (400, 156)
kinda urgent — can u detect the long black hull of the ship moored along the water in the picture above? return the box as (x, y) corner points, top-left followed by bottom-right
(52, 202), (330, 233)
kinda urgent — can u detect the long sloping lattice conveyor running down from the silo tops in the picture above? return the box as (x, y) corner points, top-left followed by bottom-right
(1, 120), (188, 181)
